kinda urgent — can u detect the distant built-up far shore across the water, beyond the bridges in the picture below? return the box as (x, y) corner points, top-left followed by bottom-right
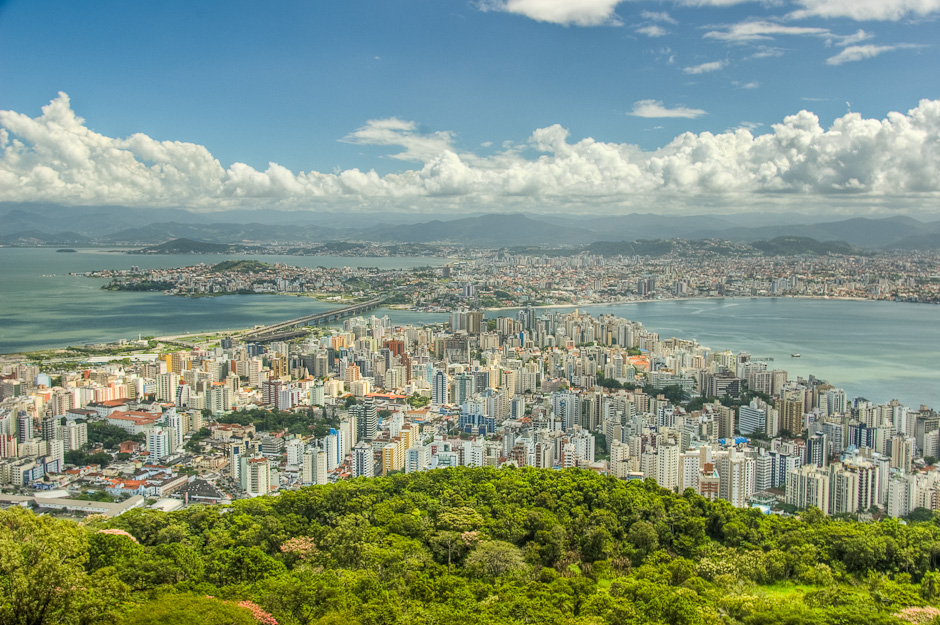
(83, 243), (940, 312)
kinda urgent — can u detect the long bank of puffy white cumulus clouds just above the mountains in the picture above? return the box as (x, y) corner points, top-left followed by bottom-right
(0, 94), (940, 212)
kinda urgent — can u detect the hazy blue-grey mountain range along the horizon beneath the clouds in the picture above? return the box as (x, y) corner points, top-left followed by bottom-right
(0, 203), (940, 249)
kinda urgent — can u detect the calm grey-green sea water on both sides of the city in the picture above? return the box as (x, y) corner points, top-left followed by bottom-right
(0, 248), (940, 408)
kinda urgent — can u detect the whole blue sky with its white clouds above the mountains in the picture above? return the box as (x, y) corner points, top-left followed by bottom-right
(0, 0), (940, 219)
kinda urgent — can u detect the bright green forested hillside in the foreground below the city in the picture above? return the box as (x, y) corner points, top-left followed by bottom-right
(0, 468), (940, 625)
